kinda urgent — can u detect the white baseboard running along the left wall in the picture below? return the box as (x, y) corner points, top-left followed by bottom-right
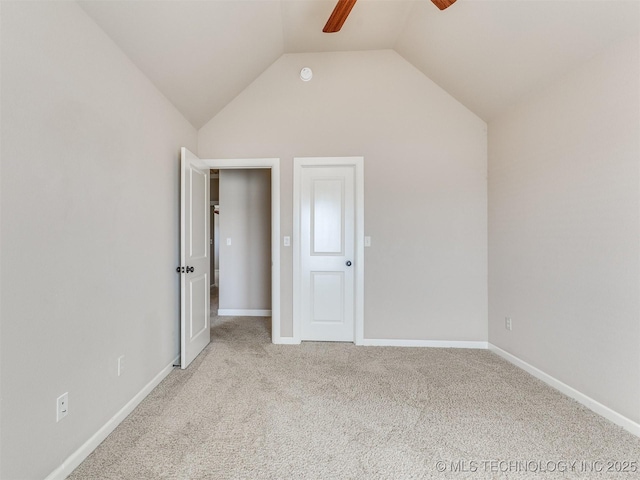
(45, 356), (180, 480)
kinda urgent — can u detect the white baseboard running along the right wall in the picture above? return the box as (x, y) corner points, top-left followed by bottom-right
(489, 343), (640, 437)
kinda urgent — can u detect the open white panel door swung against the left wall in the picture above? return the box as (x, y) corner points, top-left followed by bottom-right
(179, 147), (211, 369)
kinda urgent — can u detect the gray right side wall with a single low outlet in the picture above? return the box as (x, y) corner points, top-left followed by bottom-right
(489, 38), (640, 422)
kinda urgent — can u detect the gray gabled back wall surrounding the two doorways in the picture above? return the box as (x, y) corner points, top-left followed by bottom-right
(198, 50), (487, 341)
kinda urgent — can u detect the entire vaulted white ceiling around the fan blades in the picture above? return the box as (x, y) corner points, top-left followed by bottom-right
(79, 0), (640, 128)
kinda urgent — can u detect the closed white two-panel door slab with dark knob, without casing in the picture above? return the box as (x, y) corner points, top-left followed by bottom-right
(300, 165), (356, 342)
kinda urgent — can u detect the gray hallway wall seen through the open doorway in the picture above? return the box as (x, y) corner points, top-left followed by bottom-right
(219, 169), (271, 310)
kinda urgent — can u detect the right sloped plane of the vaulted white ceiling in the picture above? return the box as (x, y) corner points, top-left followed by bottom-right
(395, 0), (640, 121)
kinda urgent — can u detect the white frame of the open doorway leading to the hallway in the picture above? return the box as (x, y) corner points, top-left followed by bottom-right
(195, 158), (283, 343)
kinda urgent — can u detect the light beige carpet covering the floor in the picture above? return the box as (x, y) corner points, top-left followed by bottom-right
(69, 296), (640, 480)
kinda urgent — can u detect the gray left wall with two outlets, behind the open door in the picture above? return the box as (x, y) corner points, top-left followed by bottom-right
(0, 2), (196, 479)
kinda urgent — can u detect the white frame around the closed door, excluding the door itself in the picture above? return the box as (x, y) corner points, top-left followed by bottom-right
(293, 157), (365, 345)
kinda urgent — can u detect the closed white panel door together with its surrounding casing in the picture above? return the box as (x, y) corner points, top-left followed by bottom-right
(294, 157), (364, 344)
